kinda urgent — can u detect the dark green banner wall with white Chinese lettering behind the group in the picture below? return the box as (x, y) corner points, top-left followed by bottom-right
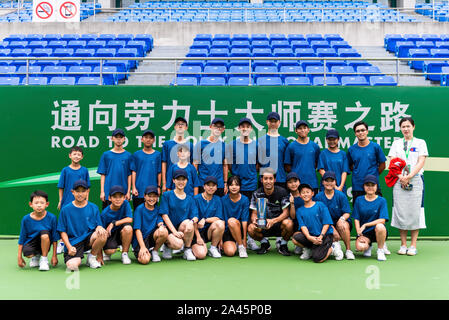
(0, 86), (449, 236)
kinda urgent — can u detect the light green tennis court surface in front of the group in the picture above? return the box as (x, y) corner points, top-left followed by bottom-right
(0, 240), (449, 300)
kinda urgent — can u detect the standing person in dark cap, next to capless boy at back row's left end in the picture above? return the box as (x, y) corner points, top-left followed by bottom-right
(97, 129), (132, 209)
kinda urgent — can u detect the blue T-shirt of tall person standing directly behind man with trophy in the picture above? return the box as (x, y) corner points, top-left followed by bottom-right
(257, 134), (289, 182)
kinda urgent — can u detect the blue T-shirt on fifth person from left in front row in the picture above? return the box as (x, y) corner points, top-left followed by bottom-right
(159, 190), (198, 229)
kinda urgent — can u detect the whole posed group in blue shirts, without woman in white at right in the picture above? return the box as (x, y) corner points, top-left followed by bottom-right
(18, 112), (389, 270)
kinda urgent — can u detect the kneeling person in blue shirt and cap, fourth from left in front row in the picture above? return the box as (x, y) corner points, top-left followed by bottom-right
(132, 186), (168, 264)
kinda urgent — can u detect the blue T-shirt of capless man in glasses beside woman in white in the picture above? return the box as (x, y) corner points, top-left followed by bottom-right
(348, 141), (387, 191)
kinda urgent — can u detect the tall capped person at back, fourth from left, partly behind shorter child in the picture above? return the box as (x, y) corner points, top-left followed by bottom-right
(161, 117), (193, 192)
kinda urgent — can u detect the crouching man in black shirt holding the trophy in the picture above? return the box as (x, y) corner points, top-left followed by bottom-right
(248, 167), (293, 256)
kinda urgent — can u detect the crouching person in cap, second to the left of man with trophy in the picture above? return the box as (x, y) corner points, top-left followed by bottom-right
(192, 176), (225, 259)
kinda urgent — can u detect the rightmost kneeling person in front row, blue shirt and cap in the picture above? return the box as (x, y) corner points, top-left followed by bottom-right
(352, 175), (389, 261)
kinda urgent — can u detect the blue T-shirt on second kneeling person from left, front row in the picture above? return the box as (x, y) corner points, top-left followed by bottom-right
(57, 202), (103, 246)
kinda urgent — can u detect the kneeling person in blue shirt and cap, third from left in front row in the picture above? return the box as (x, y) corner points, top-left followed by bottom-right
(101, 185), (133, 264)
